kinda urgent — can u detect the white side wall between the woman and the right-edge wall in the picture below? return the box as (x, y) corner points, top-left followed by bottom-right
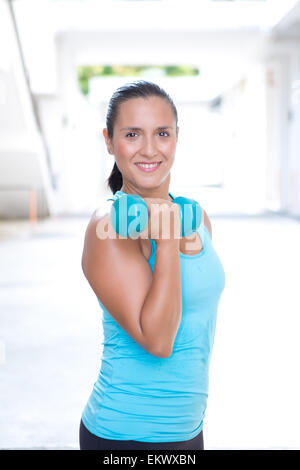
(216, 64), (267, 213)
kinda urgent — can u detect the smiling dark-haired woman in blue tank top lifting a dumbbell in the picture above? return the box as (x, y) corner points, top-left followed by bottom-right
(80, 80), (225, 450)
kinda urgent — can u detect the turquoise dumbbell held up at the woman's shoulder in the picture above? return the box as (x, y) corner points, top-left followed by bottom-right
(110, 194), (202, 237)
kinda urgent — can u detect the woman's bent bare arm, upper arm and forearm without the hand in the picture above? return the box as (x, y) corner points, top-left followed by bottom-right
(82, 211), (182, 357)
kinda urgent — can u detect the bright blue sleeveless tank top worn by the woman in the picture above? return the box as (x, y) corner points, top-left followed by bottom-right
(82, 191), (225, 442)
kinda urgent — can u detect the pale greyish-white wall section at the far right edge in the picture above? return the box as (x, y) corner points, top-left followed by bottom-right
(265, 37), (300, 217)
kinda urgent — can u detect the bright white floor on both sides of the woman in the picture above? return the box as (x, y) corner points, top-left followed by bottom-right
(0, 205), (300, 449)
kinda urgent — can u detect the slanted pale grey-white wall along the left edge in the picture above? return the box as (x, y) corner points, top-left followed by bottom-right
(0, 2), (53, 218)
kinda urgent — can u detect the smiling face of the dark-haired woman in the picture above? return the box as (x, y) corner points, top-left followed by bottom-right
(103, 96), (178, 189)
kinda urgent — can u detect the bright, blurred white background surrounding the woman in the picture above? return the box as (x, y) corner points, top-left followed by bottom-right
(0, 0), (300, 449)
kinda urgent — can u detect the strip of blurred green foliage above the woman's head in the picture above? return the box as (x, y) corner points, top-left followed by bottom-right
(77, 65), (200, 95)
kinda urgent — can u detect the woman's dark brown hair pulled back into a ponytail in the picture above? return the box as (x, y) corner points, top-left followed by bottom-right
(106, 80), (178, 194)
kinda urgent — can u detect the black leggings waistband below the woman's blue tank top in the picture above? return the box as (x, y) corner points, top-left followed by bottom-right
(79, 420), (204, 450)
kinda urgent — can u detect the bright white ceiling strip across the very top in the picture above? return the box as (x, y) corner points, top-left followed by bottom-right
(13, 0), (299, 31)
